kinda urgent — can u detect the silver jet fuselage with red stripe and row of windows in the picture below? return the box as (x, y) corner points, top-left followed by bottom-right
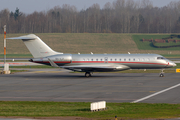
(32, 54), (176, 72)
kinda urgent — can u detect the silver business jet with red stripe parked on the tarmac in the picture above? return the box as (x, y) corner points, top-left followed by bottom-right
(7, 34), (176, 77)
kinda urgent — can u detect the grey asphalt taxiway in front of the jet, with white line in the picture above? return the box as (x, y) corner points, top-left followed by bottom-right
(0, 70), (180, 103)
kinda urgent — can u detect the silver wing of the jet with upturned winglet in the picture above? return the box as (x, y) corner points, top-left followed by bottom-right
(48, 58), (130, 72)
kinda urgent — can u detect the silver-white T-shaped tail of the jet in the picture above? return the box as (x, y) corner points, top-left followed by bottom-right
(7, 34), (63, 58)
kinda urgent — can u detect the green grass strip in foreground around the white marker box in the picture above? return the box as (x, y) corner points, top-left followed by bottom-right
(0, 101), (180, 120)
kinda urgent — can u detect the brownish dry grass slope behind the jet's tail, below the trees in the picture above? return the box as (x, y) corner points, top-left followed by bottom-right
(0, 33), (137, 54)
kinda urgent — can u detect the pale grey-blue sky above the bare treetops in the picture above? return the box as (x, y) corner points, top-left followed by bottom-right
(0, 0), (180, 13)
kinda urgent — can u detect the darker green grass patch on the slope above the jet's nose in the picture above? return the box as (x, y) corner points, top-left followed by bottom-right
(132, 34), (180, 51)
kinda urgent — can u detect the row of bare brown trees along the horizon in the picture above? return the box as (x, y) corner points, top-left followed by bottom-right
(0, 0), (180, 33)
